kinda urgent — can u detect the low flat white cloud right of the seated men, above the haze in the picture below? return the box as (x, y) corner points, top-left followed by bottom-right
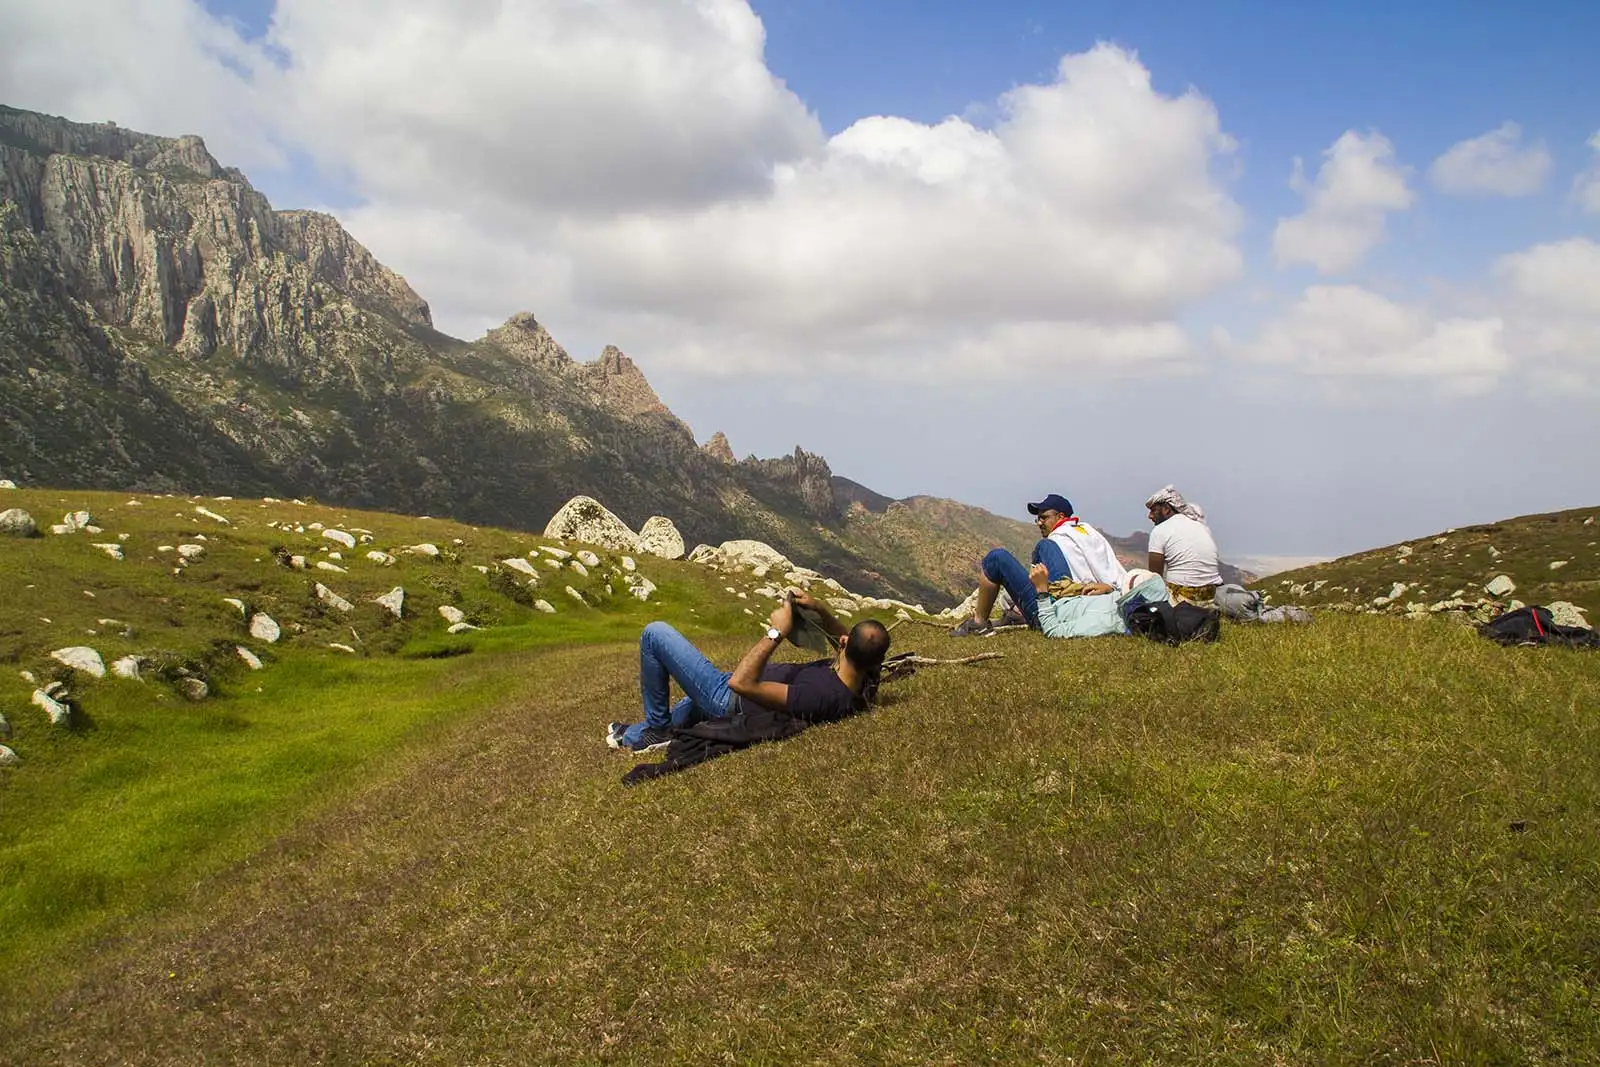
(1234, 285), (1509, 394)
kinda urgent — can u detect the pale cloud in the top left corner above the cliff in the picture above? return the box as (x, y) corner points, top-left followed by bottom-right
(0, 0), (283, 166)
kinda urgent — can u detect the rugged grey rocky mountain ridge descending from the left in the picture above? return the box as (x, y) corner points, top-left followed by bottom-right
(0, 107), (1049, 603)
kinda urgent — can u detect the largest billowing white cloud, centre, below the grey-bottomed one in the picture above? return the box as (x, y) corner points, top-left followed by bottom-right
(334, 46), (1242, 383)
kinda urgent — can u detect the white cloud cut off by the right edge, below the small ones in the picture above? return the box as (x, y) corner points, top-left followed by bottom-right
(1494, 237), (1600, 390)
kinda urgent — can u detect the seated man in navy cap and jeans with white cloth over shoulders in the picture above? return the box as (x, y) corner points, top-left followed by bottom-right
(950, 493), (1128, 637)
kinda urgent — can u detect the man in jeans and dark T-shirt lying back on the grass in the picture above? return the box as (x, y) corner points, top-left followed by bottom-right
(605, 592), (890, 782)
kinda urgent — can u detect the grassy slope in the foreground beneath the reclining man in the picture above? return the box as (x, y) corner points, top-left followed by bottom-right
(0, 491), (1600, 1064)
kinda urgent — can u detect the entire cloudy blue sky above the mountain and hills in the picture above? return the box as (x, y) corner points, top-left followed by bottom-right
(0, 0), (1600, 555)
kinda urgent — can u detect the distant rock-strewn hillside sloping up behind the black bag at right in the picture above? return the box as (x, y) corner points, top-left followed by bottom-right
(1264, 507), (1600, 622)
